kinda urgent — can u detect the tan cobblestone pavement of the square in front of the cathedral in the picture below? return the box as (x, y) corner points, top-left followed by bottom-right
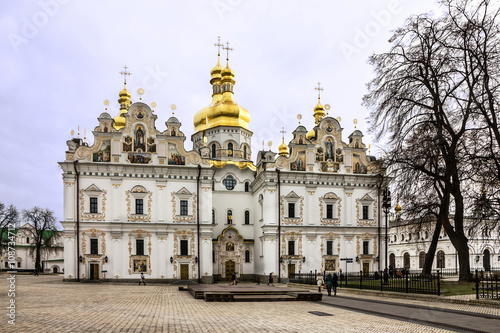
(0, 274), (458, 333)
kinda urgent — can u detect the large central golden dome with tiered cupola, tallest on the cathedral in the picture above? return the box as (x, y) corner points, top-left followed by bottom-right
(194, 60), (250, 133)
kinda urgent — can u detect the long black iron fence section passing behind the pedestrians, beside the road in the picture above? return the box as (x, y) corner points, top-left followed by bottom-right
(290, 271), (441, 296)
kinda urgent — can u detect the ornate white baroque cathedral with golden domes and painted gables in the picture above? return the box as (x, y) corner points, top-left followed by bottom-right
(59, 50), (385, 283)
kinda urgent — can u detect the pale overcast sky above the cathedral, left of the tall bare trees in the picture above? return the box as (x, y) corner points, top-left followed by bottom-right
(0, 0), (441, 220)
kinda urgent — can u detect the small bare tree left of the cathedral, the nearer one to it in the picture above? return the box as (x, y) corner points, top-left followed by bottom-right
(21, 207), (61, 272)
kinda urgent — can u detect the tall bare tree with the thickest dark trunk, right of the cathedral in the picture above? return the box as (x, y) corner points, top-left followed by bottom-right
(364, 0), (500, 280)
